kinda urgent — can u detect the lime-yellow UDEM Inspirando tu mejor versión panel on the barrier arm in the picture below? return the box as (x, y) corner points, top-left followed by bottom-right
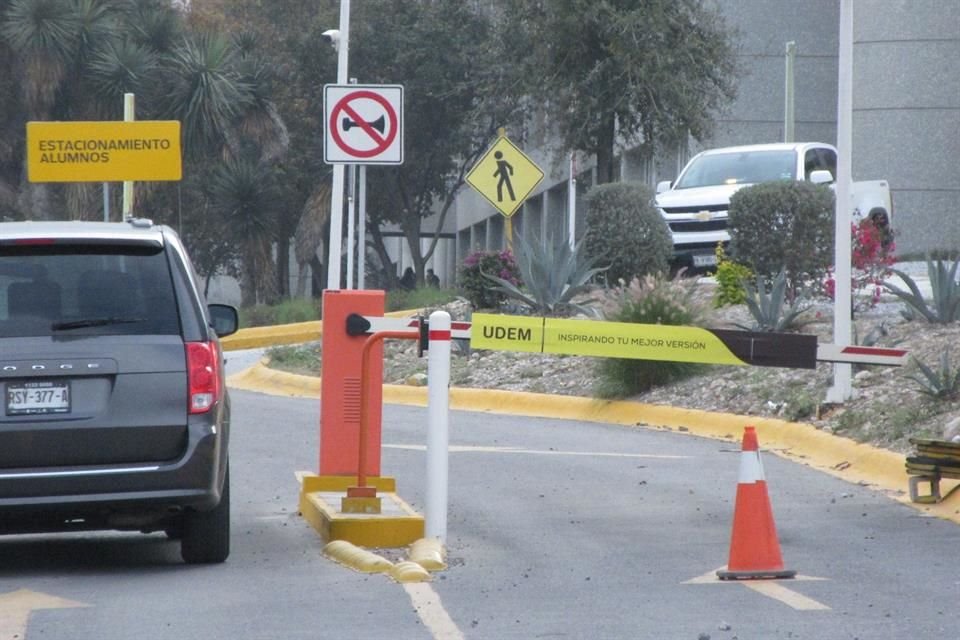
(470, 313), (748, 365)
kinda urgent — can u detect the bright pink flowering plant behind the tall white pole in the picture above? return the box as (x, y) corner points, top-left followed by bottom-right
(823, 218), (897, 310)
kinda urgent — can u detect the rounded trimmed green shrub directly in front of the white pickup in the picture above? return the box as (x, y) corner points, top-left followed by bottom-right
(728, 180), (834, 300)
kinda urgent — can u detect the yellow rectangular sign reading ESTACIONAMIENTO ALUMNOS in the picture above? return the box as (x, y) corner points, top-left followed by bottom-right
(27, 120), (182, 182)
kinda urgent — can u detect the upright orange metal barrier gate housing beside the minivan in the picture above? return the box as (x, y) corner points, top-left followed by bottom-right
(320, 290), (385, 478)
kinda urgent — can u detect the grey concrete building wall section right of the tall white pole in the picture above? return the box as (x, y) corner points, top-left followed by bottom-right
(853, 0), (960, 255)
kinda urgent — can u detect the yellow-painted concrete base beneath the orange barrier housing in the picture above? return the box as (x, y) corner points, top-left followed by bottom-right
(298, 474), (424, 548)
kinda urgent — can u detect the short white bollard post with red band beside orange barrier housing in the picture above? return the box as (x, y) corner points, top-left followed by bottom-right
(424, 311), (450, 543)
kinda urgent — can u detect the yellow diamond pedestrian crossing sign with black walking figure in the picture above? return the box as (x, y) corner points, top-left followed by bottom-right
(466, 136), (543, 218)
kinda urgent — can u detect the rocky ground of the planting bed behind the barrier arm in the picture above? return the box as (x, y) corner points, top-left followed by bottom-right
(264, 284), (960, 452)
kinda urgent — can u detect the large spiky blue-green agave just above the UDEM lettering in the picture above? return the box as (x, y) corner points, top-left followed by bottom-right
(483, 236), (607, 316)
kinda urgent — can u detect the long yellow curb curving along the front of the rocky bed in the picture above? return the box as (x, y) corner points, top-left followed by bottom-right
(234, 364), (960, 524)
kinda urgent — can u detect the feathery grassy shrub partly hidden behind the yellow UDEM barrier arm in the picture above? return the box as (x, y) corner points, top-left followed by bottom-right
(594, 276), (705, 398)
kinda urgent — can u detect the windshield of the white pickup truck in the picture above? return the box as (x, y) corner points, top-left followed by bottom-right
(674, 151), (797, 189)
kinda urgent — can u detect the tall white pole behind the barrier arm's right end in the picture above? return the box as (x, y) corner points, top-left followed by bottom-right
(827, 0), (853, 402)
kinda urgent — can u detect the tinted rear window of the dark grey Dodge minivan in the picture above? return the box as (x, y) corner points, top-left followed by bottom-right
(0, 243), (180, 338)
